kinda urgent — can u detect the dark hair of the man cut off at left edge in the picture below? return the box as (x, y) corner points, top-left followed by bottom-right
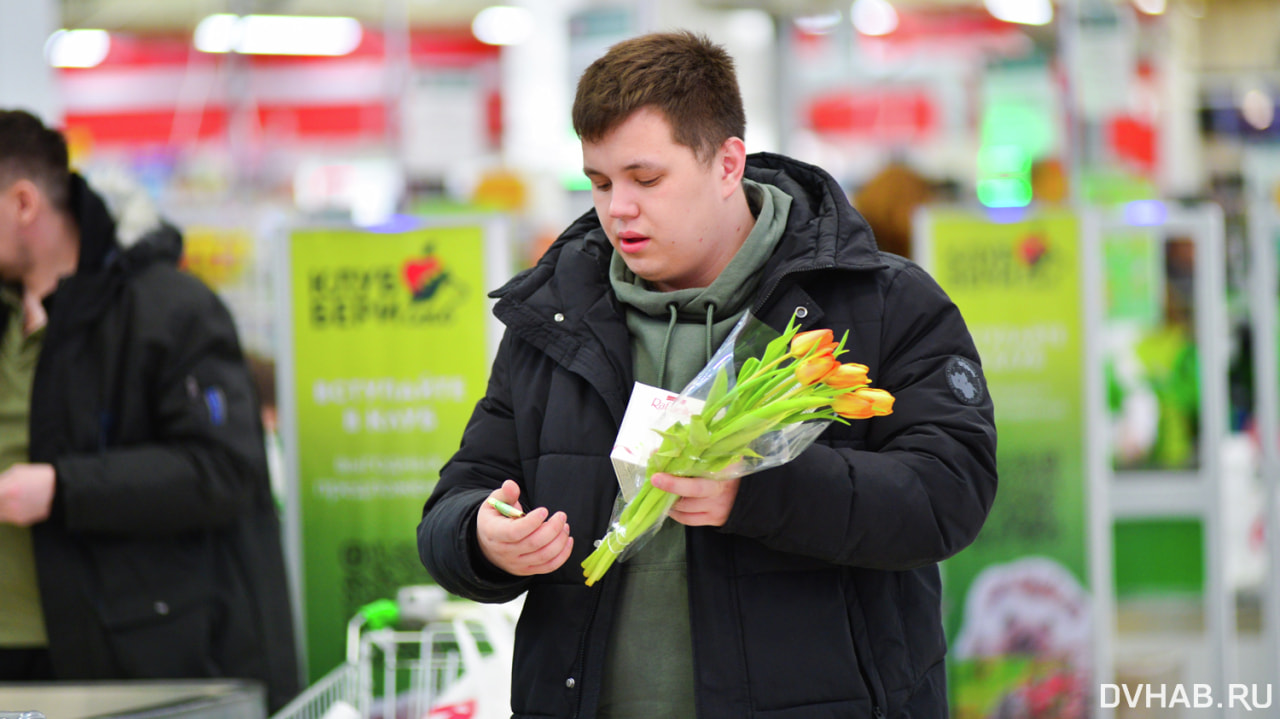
(0, 110), (70, 215)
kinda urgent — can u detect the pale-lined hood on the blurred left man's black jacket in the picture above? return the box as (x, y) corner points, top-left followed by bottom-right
(70, 173), (182, 273)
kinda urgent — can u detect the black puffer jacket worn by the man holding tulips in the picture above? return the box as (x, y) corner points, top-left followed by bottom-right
(419, 155), (996, 719)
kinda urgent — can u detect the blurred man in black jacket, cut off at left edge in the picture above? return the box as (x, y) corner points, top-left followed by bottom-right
(0, 110), (298, 709)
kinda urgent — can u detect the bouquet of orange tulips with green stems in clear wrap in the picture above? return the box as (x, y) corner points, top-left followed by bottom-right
(582, 315), (893, 586)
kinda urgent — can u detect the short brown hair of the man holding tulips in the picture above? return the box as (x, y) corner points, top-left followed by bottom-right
(573, 32), (746, 161)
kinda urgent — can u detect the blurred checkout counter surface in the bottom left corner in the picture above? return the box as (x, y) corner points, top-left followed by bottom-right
(0, 679), (266, 719)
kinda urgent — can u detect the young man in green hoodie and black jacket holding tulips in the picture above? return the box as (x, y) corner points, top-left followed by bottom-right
(419, 33), (996, 719)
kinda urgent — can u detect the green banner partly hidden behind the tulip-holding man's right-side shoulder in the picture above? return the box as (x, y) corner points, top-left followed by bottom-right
(922, 210), (1092, 719)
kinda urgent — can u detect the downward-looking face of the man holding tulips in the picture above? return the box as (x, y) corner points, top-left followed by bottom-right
(582, 107), (750, 292)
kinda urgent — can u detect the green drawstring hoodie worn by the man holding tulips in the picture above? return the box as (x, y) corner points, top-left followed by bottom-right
(599, 179), (791, 719)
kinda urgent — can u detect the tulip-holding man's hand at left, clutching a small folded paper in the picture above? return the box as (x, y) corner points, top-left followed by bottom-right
(476, 480), (573, 577)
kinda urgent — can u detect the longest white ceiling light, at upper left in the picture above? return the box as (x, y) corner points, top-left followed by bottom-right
(195, 14), (364, 56)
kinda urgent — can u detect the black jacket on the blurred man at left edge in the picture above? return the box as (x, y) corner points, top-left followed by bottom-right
(0, 177), (298, 709)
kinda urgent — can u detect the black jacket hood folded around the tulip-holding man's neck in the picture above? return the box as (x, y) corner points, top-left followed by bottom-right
(490, 152), (886, 312)
